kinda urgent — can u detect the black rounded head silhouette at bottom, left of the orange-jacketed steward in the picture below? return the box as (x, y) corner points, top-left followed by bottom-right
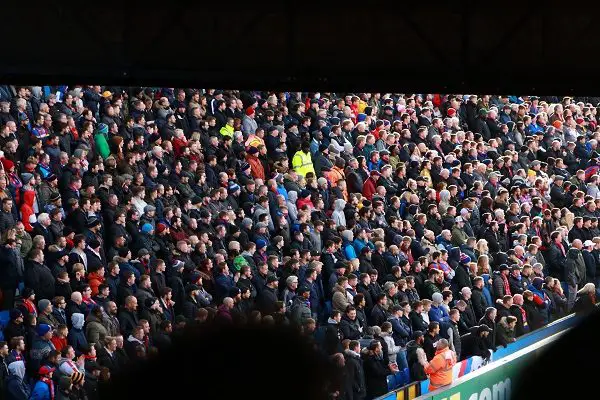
(99, 325), (335, 400)
